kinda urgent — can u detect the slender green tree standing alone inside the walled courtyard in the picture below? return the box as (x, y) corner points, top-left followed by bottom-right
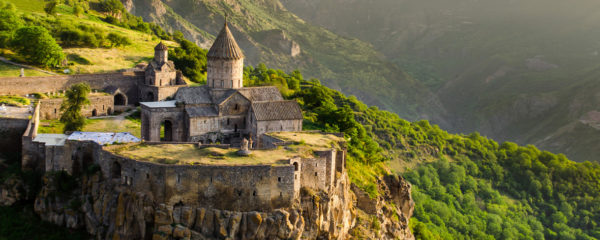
(60, 83), (91, 132)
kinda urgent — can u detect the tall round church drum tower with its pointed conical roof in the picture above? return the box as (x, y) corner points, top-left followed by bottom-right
(206, 21), (244, 89)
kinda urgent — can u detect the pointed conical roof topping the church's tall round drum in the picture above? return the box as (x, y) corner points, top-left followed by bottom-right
(207, 22), (244, 59)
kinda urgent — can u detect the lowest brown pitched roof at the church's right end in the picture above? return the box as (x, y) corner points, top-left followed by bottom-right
(252, 100), (302, 121)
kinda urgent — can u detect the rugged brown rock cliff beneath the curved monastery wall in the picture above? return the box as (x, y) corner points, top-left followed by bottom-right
(29, 168), (414, 239)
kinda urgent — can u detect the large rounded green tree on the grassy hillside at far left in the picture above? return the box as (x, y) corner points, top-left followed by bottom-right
(12, 26), (65, 67)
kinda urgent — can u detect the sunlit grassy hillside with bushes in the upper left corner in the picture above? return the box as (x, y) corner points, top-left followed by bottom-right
(0, 0), (171, 73)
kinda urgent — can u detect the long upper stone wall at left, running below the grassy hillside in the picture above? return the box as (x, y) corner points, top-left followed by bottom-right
(0, 72), (144, 104)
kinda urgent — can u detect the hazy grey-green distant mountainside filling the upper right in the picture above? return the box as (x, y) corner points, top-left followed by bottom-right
(282, 0), (600, 161)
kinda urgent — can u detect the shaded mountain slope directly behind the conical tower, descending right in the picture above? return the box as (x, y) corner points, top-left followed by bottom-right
(124, 0), (442, 119)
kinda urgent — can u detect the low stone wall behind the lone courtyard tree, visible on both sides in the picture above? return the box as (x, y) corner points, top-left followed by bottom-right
(40, 95), (114, 120)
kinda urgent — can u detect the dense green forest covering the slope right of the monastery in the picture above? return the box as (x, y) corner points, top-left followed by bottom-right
(236, 64), (600, 239)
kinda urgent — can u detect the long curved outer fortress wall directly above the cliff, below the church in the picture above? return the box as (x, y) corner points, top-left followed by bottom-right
(96, 151), (299, 211)
